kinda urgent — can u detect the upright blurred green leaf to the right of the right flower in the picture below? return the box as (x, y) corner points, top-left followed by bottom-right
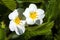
(46, 0), (58, 22)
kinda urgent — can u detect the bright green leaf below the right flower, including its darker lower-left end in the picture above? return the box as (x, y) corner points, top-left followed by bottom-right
(20, 22), (54, 40)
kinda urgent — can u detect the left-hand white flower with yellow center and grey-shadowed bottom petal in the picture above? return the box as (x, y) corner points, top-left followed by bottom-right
(9, 9), (25, 35)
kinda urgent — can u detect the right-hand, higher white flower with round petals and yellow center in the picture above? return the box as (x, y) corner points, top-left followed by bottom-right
(23, 4), (45, 25)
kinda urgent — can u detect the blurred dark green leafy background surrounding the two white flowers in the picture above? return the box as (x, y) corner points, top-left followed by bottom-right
(0, 0), (60, 40)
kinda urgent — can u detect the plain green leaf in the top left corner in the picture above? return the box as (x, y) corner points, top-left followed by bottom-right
(2, 0), (16, 10)
